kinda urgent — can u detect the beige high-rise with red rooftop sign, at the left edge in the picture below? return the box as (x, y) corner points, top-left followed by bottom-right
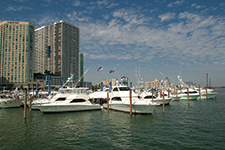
(0, 21), (35, 83)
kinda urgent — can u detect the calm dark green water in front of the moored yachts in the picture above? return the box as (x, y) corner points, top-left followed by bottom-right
(0, 89), (225, 150)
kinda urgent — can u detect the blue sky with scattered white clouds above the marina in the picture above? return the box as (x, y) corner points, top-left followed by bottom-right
(0, 0), (225, 86)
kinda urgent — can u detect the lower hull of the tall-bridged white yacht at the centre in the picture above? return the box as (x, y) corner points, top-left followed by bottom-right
(103, 104), (156, 114)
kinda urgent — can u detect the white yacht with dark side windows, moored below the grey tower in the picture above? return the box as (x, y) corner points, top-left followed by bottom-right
(35, 88), (101, 113)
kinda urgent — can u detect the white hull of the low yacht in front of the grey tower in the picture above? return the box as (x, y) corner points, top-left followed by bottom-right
(39, 104), (101, 113)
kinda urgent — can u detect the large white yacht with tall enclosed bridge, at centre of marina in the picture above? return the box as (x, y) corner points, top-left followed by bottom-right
(103, 85), (159, 114)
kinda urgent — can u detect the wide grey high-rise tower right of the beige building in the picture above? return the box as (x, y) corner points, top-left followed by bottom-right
(34, 21), (80, 79)
